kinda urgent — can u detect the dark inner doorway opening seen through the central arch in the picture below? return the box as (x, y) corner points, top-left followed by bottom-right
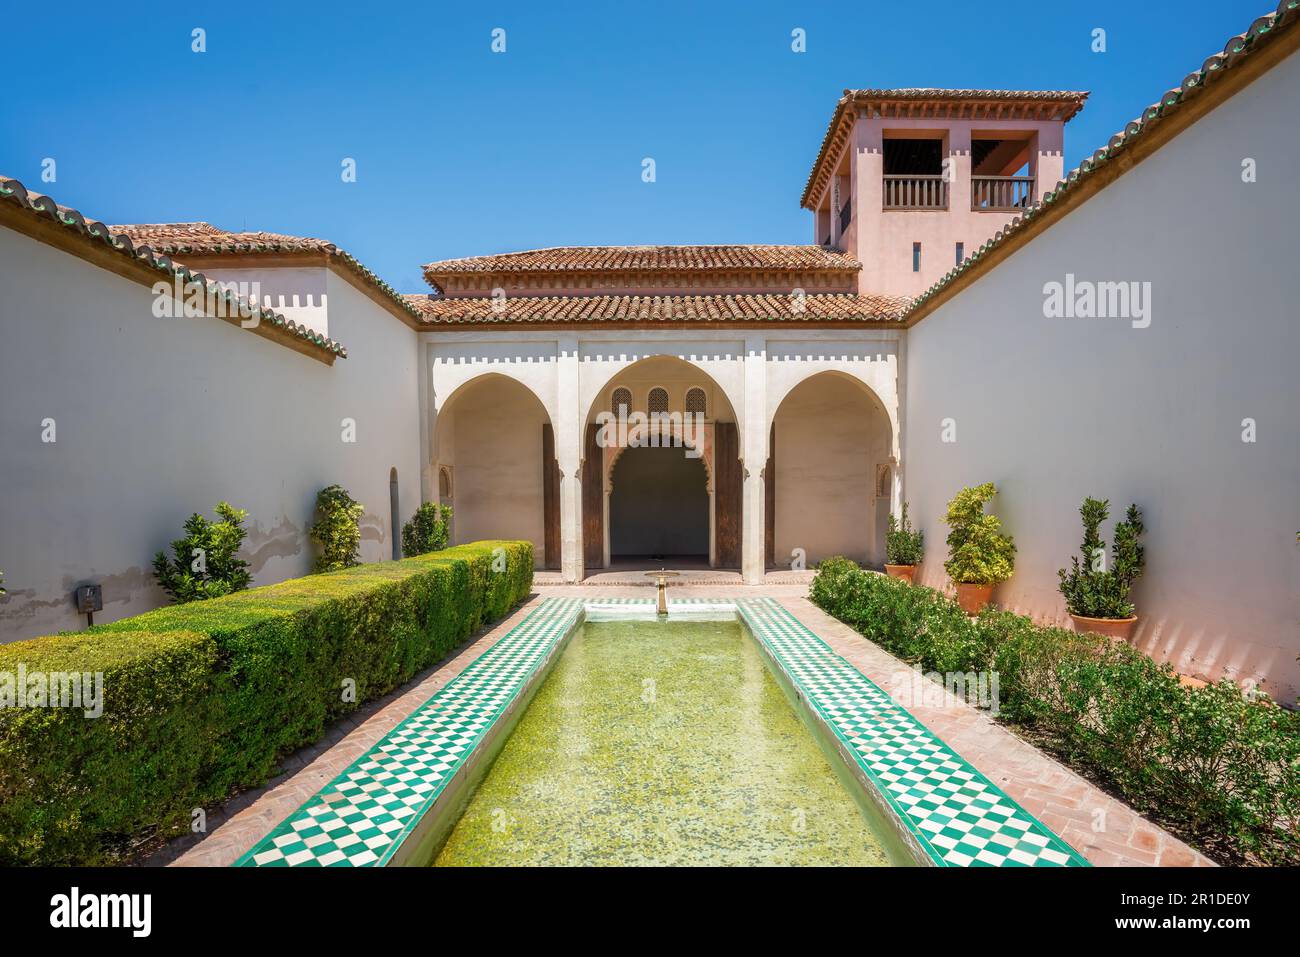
(610, 446), (710, 564)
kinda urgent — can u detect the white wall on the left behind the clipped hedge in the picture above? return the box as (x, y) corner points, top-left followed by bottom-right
(0, 228), (420, 641)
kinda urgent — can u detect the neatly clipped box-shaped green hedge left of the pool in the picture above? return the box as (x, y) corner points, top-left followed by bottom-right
(0, 541), (533, 865)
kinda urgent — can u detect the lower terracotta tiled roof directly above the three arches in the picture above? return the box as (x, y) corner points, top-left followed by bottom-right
(407, 293), (910, 325)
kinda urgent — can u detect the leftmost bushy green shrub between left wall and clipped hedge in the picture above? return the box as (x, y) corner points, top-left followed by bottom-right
(153, 502), (252, 603)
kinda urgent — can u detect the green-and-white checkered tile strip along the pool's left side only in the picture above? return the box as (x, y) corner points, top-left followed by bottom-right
(235, 598), (582, 867)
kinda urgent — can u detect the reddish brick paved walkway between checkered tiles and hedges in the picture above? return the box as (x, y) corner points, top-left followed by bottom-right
(159, 582), (1212, 866)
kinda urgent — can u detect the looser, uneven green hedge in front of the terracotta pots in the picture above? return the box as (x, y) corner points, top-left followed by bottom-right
(811, 558), (1300, 865)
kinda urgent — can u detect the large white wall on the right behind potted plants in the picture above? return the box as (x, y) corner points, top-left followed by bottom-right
(904, 56), (1300, 701)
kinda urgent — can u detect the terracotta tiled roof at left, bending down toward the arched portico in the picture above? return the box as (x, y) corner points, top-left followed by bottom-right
(109, 222), (417, 319)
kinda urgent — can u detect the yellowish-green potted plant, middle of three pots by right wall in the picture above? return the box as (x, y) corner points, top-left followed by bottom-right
(944, 482), (1015, 615)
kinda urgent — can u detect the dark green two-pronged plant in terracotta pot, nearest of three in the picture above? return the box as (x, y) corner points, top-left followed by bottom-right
(1057, 498), (1145, 641)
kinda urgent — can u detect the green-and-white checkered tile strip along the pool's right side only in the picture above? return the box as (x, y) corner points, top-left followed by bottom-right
(736, 598), (1088, 867)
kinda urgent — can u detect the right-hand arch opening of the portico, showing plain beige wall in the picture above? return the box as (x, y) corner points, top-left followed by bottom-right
(768, 372), (893, 567)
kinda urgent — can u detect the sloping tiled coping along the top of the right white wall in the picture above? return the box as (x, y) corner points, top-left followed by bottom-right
(904, 0), (1300, 325)
